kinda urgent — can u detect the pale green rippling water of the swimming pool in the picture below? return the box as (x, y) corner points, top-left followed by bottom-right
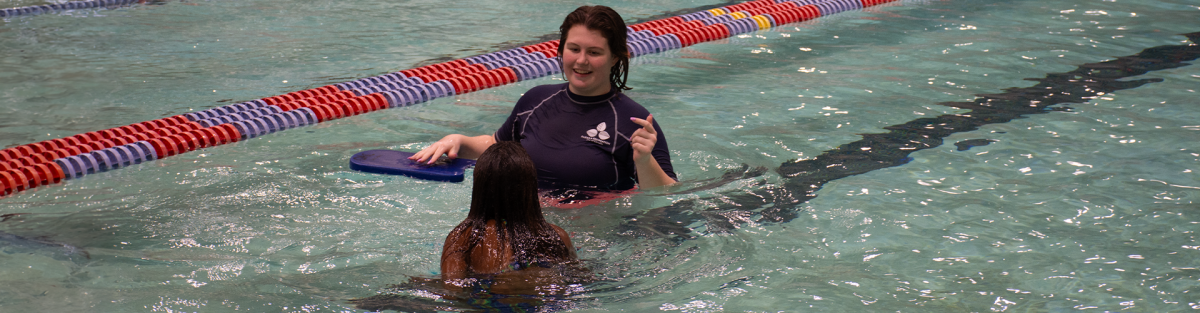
(0, 1), (1200, 312)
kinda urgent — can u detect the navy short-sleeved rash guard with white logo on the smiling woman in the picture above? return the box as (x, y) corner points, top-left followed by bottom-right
(494, 84), (678, 189)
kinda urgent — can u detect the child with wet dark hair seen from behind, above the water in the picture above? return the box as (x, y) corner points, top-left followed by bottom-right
(442, 142), (576, 291)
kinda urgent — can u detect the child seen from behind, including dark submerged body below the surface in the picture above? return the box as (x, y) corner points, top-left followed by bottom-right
(349, 142), (580, 312)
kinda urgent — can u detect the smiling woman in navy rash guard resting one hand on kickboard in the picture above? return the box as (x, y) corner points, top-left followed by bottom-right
(412, 6), (677, 191)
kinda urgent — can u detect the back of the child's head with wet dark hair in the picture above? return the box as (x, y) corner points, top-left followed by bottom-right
(468, 142), (542, 223)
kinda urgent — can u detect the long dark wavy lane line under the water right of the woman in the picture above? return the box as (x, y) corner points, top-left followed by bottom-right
(619, 32), (1200, 238)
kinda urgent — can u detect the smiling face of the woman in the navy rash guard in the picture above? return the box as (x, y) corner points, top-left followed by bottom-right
(562, 25), (617, 96)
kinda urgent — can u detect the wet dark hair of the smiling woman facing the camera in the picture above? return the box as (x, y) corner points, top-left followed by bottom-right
(558, 6), (631, 90)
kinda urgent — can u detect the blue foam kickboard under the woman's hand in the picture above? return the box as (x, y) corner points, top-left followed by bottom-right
(350, 150), (475, 182)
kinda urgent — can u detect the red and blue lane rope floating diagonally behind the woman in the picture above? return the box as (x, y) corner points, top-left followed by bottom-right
(0, 0), (895, 197)
